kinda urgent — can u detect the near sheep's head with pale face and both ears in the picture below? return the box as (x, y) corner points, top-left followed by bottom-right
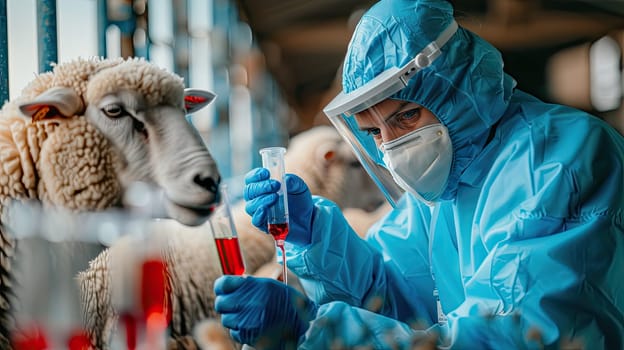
(20, 59), (220, 225)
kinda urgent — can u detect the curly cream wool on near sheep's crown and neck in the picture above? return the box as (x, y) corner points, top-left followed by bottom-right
(0, 58), (190, 349)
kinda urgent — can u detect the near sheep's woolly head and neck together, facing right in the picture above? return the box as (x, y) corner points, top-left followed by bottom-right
(0, 58), (220, 349)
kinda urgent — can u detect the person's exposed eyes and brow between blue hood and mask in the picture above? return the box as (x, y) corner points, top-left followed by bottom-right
(355, 99), (440, 147)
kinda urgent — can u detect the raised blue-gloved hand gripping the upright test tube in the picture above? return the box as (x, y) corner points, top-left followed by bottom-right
(243, 168), (314, 245)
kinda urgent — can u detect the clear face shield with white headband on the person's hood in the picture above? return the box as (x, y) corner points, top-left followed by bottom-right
(323, 21), (457, 206)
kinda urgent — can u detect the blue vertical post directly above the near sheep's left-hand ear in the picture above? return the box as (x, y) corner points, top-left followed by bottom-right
(37, 0), (58, 73)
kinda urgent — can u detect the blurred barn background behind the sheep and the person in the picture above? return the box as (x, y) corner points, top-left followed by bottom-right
(0, 0), (624, 192)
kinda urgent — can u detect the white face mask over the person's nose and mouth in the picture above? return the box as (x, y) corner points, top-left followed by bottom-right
(381, 123), (453, 205)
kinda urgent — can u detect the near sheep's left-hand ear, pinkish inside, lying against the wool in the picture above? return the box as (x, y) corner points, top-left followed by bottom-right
(19, 87), (84, 122)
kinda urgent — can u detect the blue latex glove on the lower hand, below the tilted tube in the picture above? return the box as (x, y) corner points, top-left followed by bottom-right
(214, 275), (318, 349)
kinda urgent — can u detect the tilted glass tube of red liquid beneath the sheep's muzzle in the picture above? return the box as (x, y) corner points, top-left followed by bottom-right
(209, 184), (245, 275)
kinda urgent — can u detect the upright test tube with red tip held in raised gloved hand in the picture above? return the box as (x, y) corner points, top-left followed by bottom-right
(260, 147), (288, 283)
